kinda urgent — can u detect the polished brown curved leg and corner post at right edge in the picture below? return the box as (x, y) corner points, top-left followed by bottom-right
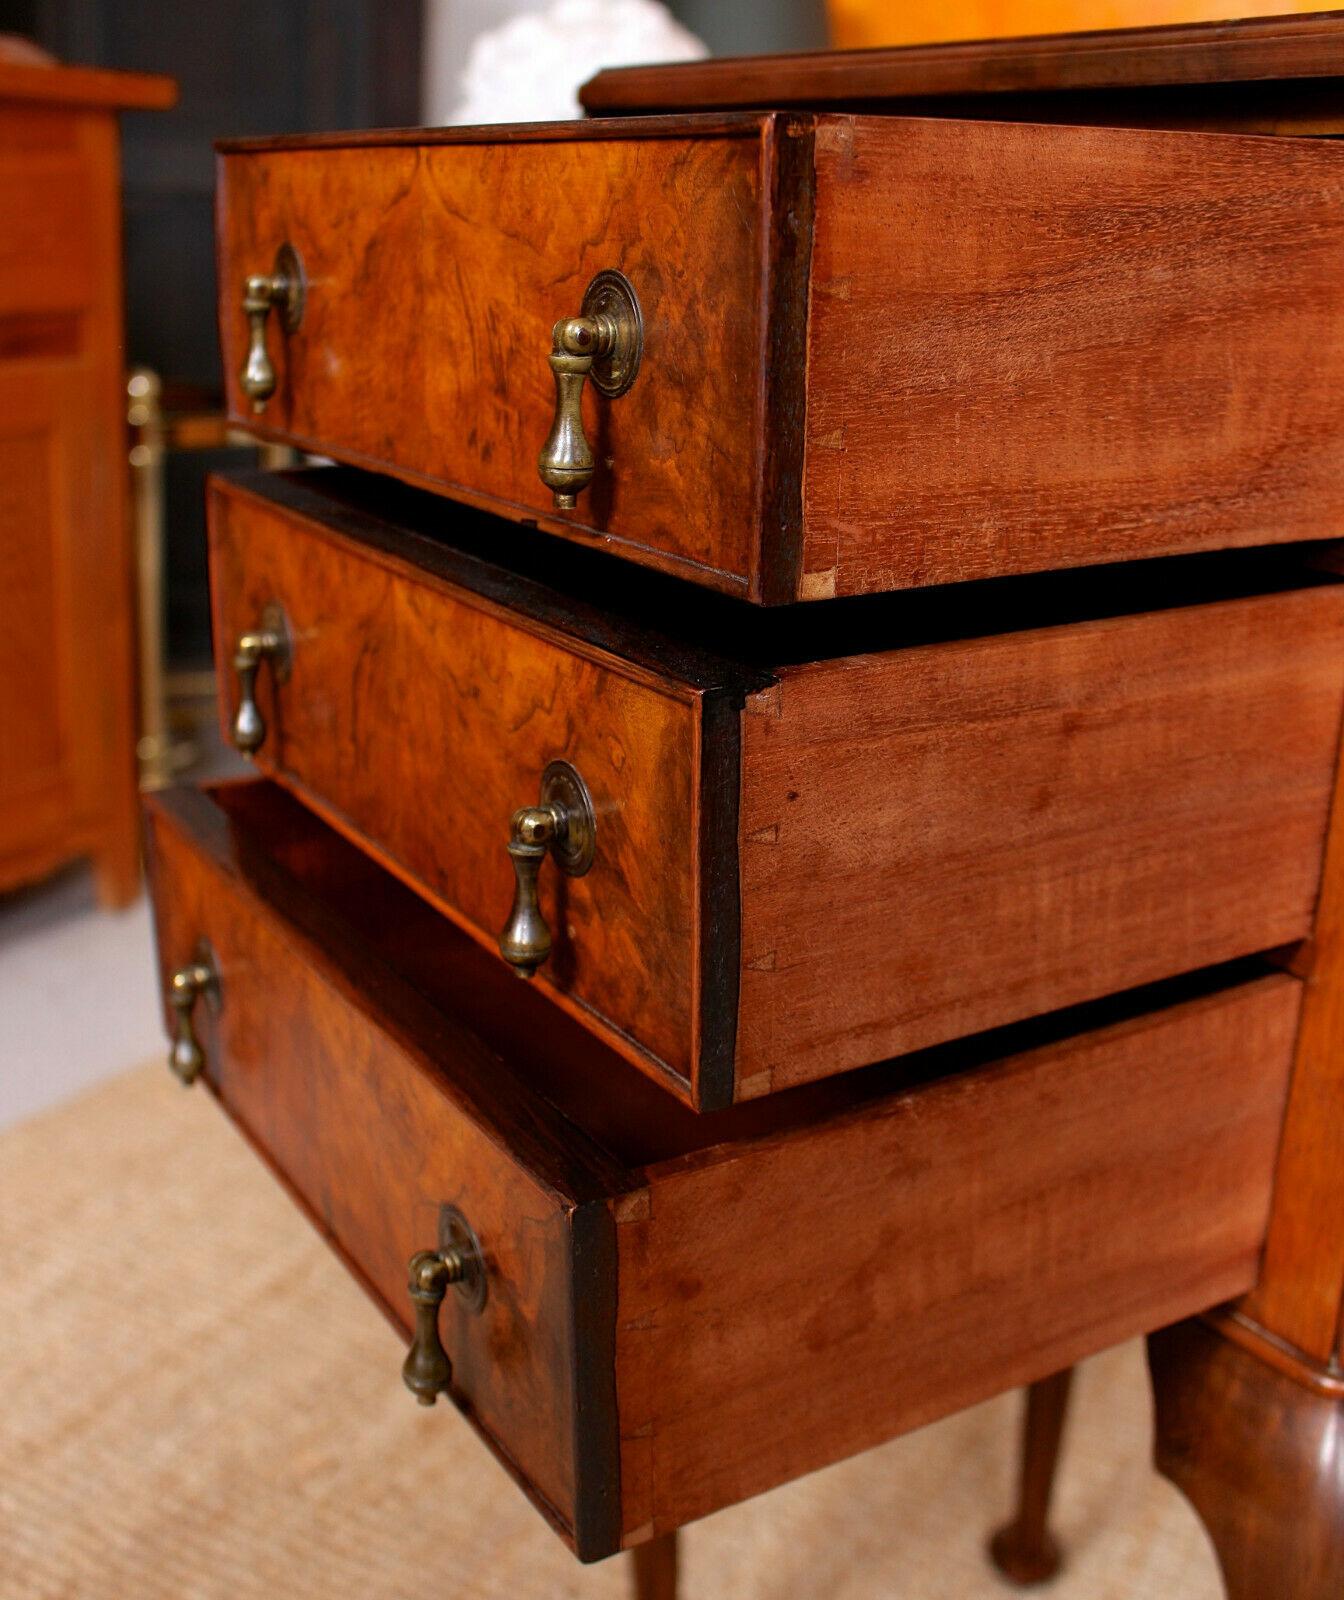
(1126, 524), (1344, 1600)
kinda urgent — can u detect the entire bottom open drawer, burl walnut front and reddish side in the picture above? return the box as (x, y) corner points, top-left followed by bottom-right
(149, 784), (1299, 1558)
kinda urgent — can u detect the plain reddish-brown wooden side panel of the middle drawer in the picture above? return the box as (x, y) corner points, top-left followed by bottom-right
(738, 587), (1344, 1094)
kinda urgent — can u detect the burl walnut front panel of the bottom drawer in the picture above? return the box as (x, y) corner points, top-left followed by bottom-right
(147, 794), (619, 1555)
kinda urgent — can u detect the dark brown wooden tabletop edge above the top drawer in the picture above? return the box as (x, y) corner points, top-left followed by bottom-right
(579, 11), (1344, 115)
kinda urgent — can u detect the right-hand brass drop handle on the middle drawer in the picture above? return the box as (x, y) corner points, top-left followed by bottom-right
(499, 762), (597, 978)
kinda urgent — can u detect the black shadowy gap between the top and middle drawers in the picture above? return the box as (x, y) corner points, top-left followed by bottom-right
(244, 467), (1339, 681)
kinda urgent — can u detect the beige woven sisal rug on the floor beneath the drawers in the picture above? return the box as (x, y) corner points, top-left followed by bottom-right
(0, 1066), (1221, 1600)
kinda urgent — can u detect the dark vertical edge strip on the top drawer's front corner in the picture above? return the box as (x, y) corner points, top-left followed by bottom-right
(757, 117), (816, 605)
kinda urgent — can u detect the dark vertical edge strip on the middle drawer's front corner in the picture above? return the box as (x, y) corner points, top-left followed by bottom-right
(693, 694), (742, 1112)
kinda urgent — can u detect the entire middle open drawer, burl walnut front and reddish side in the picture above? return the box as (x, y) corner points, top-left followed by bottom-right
(211, 472), (1344, 1109)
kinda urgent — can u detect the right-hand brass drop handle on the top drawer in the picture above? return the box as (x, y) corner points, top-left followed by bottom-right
(536, 272), (643, 510)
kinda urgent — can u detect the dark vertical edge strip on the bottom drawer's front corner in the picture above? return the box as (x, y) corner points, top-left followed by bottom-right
(570, 1200), (621, 1562)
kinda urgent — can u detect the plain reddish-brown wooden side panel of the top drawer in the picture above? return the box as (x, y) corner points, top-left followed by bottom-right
(802, 117), (1344, 595)
